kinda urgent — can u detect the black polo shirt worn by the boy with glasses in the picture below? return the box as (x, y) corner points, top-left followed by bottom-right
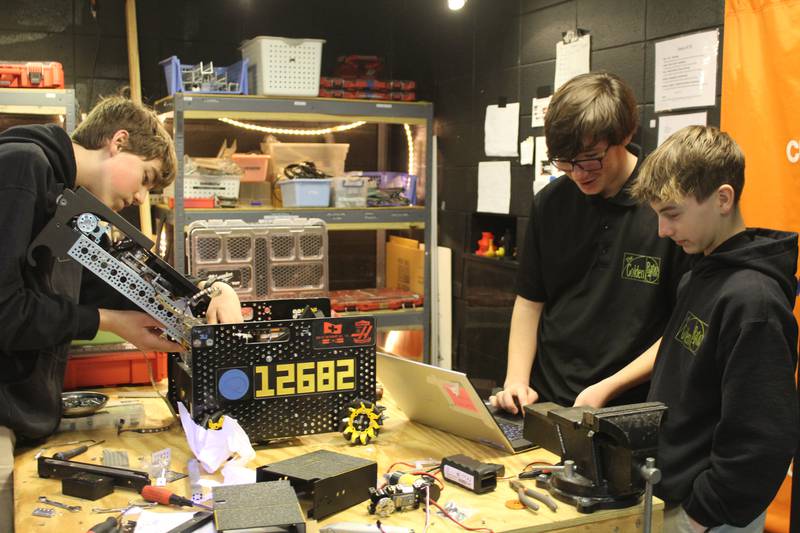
(517, 145), (689, 405)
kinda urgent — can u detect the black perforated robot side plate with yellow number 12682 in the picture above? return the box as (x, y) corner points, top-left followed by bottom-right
(190, 317), (375, 441)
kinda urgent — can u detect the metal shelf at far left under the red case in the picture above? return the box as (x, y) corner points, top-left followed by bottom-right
(0, 89), (77, 133)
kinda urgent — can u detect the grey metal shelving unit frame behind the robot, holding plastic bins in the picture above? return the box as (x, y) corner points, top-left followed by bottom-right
(154, 93), (438, 361)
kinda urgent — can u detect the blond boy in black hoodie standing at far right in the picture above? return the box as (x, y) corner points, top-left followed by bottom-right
(632, 126), (800, 533)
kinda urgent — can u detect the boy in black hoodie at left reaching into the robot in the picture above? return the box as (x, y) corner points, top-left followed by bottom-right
(0, 97), (242, 533)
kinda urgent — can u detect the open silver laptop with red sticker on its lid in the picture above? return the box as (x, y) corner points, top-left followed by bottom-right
(377, 352), (533, 453)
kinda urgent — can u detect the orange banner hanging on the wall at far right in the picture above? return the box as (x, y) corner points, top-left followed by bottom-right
(721, 0), (800, 533)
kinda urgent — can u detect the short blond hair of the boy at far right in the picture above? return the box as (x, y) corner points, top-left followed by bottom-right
(631, 126), (744, 203)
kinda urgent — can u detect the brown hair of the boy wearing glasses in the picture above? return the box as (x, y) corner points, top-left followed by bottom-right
(544, 72), (639, 159)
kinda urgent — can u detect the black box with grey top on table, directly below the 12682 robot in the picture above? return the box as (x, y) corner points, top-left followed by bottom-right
(256, 450), (378, 520)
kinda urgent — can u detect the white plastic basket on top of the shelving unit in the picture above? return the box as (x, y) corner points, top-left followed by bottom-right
(242, 36), (325, 96)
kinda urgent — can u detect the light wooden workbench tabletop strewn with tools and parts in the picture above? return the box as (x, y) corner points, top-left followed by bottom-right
(14, 383), (663, 533)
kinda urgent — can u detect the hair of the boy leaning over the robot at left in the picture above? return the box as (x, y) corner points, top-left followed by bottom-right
(72, 96), (178, 189)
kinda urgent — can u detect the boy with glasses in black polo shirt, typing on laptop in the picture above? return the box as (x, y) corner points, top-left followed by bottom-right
(492, 72), (688, 413)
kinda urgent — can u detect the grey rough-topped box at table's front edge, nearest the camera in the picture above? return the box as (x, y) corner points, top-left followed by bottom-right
(212, 481), (306, 533)
